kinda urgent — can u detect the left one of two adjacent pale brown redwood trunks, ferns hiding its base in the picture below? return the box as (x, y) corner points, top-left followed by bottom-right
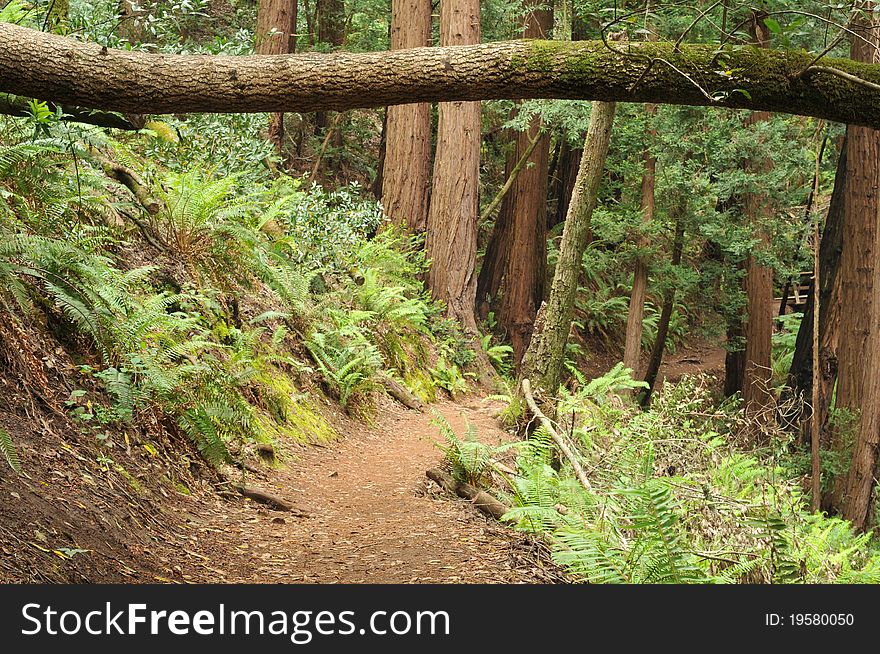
(382, 0), (431, 233)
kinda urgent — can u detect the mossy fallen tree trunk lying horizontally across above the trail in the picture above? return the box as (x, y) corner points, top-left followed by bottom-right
(0, 23), (880, 129)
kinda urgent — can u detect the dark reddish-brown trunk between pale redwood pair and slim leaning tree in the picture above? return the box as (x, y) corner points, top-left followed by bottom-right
(493, 0), (553, 366)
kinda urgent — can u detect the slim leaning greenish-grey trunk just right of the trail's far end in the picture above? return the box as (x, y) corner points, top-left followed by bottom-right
(520, 102), (617, 397)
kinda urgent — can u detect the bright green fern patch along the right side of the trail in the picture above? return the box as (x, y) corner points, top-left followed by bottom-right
(506, 373), (880, 583)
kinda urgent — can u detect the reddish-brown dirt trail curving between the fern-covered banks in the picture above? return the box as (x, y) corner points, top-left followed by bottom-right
(187, 400), (555, 583)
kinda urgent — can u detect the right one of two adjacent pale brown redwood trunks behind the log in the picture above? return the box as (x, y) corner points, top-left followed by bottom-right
(426, 0), (480, 334)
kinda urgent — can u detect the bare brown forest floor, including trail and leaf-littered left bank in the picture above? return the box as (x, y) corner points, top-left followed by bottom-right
(0, 334), (724, 583)
